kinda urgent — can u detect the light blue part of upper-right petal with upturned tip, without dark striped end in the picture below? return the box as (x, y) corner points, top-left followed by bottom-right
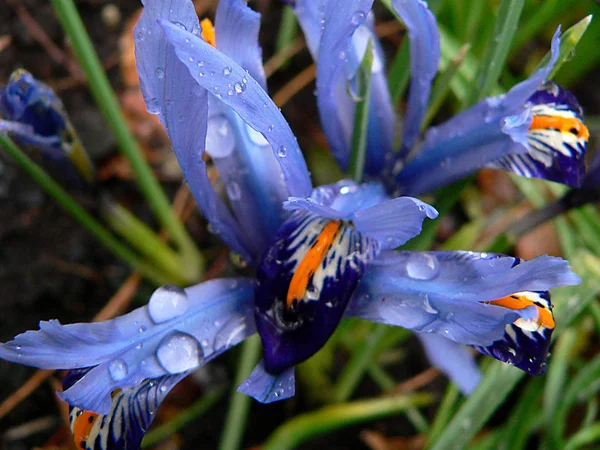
(394, 27), (560, 195)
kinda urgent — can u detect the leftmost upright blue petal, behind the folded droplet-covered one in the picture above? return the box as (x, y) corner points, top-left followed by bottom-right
(134, 0), (251, 260)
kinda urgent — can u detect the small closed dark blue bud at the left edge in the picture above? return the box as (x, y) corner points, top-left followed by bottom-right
(0, 69), (94, 185)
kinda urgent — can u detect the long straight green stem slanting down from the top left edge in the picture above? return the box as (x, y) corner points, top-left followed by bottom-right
(52, 0), (203, 278)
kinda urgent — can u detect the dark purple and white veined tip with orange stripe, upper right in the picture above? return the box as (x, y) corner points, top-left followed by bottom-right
(487, 83), (589, 187)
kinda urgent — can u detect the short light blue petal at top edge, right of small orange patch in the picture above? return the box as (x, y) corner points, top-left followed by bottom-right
(215, 0), (267, 91)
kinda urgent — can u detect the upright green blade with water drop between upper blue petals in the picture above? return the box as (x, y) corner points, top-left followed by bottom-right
(348, 39), (373, 183)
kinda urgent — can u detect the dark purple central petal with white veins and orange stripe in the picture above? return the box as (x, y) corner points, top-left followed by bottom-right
(255, 210), (379, 375)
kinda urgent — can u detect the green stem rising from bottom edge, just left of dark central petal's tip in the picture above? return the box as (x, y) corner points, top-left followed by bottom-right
(219, 335), (261, 450)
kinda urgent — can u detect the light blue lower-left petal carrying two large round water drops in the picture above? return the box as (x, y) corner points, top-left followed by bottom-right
(0, 279), (255, 415)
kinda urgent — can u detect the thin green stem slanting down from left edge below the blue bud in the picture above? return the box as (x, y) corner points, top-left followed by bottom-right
(0, 136), (171, 285)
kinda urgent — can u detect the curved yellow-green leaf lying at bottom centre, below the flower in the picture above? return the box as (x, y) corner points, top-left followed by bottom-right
(262, 393), (433, 450)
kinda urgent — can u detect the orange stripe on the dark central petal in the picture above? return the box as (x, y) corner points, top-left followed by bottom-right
(286, 220), (342, 308)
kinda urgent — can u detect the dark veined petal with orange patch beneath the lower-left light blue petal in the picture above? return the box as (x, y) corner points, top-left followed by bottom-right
(63, 369), (187, 450)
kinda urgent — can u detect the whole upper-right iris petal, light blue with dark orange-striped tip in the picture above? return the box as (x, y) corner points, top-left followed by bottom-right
(395, 28), (572, 195)
